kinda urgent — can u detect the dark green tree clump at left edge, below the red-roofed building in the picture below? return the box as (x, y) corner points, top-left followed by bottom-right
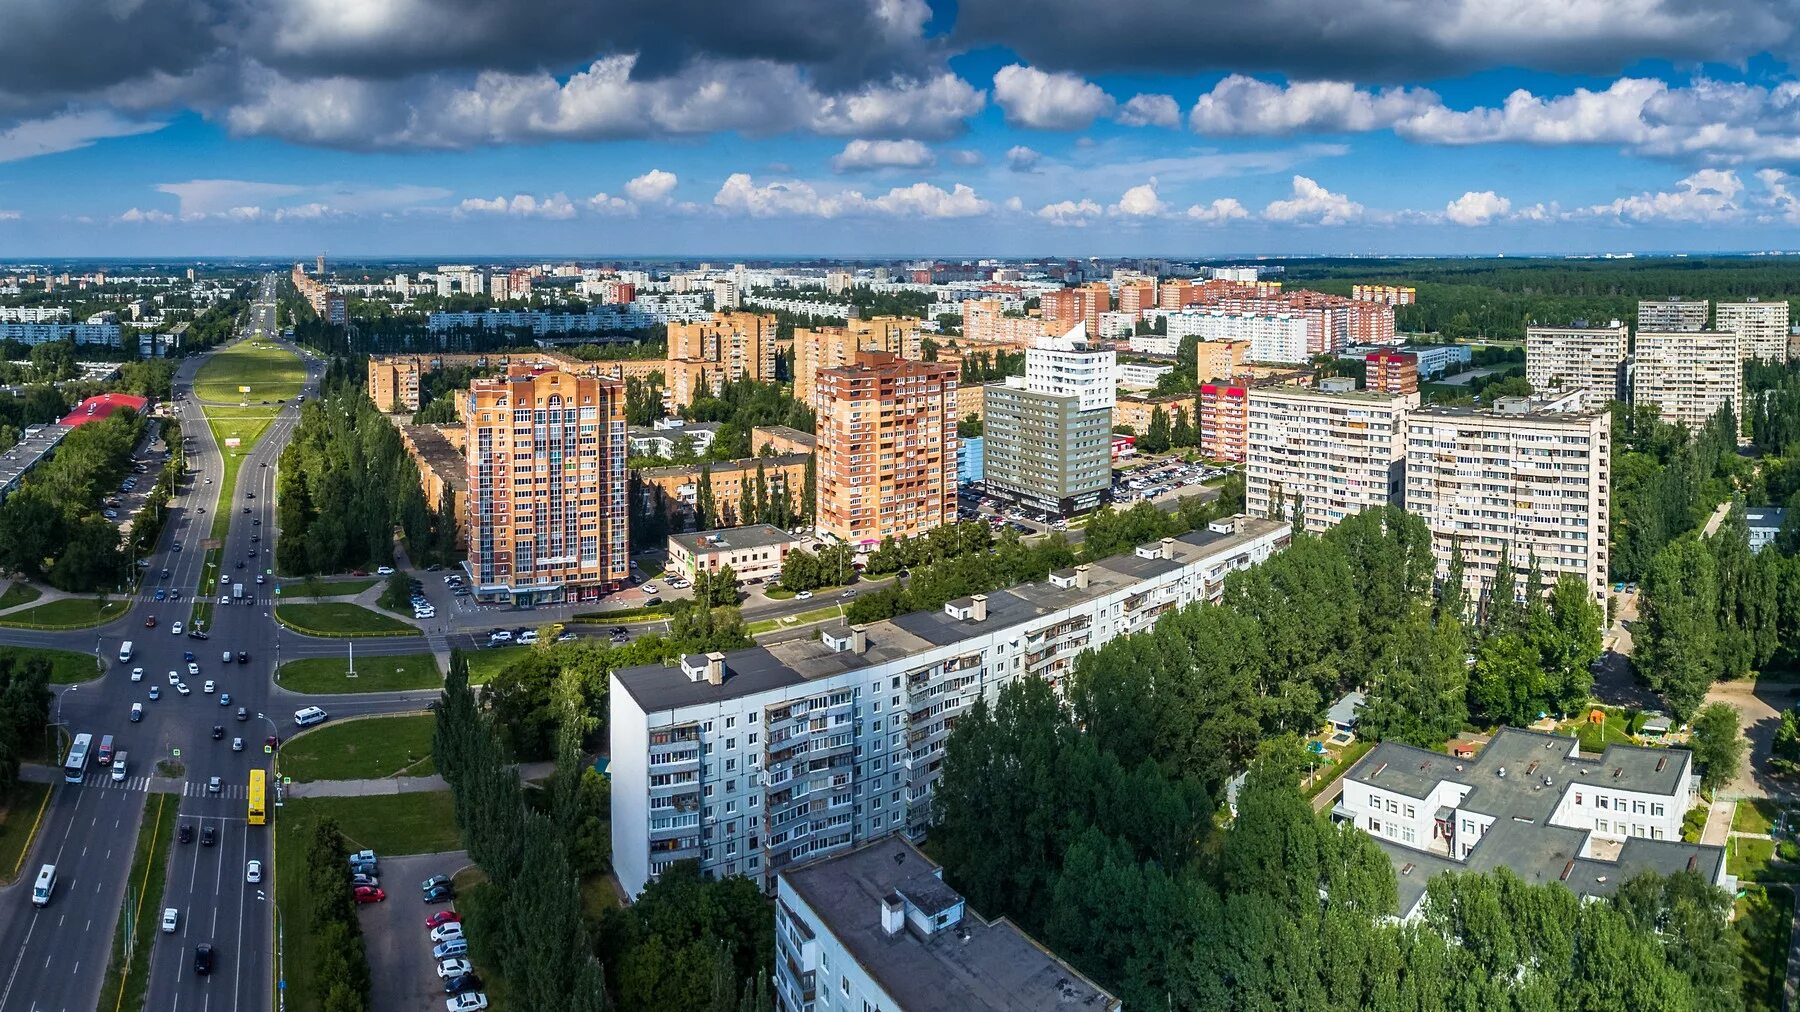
(0, 409), (148, 592)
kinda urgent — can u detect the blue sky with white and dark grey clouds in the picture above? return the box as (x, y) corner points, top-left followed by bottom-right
(10, 0), (1800, 258)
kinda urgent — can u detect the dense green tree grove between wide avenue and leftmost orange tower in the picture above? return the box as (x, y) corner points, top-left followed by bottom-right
(275, 360), (457, 574)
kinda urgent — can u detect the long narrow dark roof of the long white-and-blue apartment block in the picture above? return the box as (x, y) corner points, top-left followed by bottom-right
(614, 511), (1287, 713)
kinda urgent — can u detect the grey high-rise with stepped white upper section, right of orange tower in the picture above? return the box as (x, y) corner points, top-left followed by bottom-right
(983, 324), (1118, 517)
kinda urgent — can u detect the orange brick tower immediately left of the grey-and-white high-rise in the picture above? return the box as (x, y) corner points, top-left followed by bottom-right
(817, 351), (958, 544)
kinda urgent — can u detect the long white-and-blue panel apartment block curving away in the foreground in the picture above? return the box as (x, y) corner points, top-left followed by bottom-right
(608, 517), (1291, 897)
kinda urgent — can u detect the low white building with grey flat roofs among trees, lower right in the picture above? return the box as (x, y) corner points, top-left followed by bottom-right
(1332, 727), (1737, 920)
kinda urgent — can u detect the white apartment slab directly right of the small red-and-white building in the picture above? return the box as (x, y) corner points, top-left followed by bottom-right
(1244, 376), (1418, 533)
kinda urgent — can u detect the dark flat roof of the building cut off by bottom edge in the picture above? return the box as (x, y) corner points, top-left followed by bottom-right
(781, 836), (1118, 1012)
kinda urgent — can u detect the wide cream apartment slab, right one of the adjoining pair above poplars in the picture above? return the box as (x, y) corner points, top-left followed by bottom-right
(1406, 398), (1613, 601)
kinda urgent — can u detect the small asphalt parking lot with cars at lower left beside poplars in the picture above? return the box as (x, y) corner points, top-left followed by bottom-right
(358, 850), (481, 1012)
